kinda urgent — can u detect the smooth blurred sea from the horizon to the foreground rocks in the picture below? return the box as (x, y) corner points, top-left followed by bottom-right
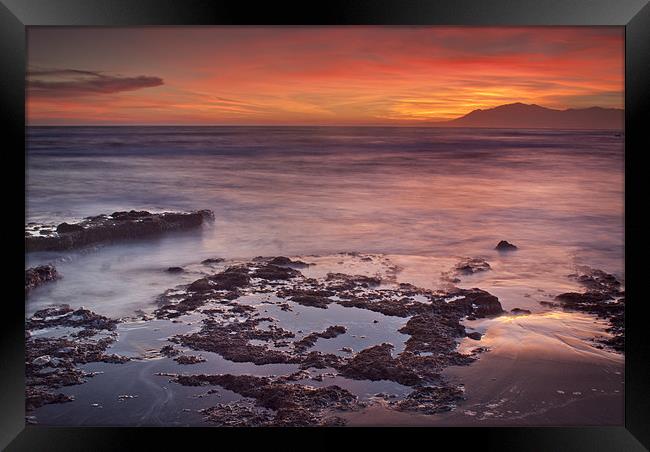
(26, 127), (624, 318)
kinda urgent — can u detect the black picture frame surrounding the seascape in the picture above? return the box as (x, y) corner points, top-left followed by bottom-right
(0, 0), (650, 451)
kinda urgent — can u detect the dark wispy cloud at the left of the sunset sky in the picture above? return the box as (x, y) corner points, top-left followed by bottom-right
(27, 69), (164, 97)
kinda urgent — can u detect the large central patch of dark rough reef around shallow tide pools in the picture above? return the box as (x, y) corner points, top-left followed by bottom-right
(148, 258), (503, 425)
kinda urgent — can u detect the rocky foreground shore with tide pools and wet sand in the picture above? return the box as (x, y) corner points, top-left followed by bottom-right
(28, 213), (623, 425)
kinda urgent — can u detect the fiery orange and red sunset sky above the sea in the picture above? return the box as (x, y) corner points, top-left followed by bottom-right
(27, 26), (624, 125)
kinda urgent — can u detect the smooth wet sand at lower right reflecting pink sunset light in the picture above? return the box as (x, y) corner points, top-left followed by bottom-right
(344, 311), (625, 426)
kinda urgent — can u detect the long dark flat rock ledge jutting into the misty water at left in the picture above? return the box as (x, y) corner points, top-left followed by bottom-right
(25, 210), (214, 252)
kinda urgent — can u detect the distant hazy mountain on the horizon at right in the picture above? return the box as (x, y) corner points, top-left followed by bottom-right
(439, 102), (625, 130)
